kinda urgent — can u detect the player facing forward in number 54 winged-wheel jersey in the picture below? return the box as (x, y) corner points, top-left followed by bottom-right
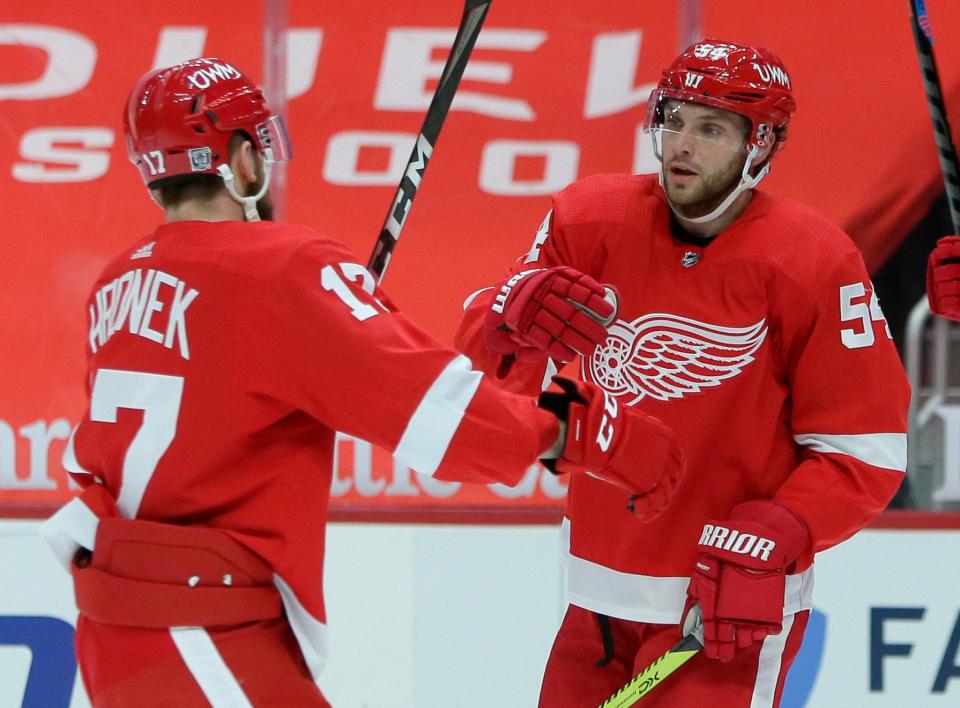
(457, 40), (909, 708)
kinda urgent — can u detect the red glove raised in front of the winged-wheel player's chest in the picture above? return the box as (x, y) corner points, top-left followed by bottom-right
(483, 266), (616, 362)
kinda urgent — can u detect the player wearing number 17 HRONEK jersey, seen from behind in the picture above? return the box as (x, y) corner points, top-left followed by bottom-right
(35, 59), (682, 706)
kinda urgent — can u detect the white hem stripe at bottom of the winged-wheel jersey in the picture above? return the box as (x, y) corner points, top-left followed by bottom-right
(560, 518), (813, 624)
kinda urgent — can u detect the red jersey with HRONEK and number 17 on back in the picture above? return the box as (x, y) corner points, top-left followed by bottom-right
(43, 221), (559, 677)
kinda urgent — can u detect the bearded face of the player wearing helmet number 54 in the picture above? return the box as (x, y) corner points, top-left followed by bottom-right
(661, 101), (748, 218)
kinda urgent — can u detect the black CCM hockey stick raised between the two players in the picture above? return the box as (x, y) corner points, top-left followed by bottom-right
(367, 0), (492, 282)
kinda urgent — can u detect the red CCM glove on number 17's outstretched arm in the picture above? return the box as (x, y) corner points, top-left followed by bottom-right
(538, 376), (686, 521)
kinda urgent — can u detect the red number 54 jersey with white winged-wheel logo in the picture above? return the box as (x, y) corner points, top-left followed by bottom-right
(457, 175), (909, 623)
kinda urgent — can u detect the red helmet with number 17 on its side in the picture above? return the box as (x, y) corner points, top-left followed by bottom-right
(123, 58), (290, 187)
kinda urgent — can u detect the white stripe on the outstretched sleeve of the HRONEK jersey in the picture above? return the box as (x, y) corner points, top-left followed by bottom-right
(393, 354), (483, 475)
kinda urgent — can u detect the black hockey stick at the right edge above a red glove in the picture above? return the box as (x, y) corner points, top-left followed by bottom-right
(910, 0), (960, 233)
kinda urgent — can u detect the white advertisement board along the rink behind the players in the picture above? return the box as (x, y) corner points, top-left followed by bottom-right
(0, 521), (960, 708)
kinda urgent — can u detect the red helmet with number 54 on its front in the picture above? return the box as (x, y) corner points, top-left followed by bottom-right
(645, 39), (797, 156)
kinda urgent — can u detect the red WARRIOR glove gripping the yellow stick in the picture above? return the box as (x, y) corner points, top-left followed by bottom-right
(684, 500), (810, 661)
